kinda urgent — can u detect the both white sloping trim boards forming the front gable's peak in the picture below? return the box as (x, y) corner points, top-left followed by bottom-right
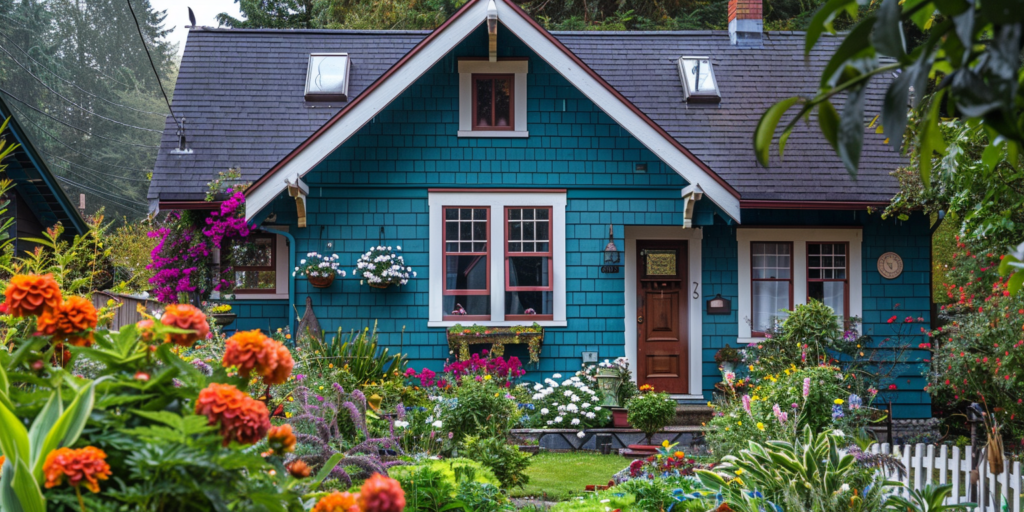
(246, 0), (739, 222)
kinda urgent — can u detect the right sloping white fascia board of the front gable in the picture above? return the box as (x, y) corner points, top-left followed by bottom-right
(498, 0), (739, 222)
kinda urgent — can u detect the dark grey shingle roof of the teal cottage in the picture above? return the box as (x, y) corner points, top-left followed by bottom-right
(150, 30), (903, 201)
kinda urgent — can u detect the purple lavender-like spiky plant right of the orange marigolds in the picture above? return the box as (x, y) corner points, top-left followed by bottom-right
(287, 383), (402, 485)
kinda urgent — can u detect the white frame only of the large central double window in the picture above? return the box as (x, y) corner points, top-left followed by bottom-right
(427, 189), (568, 327)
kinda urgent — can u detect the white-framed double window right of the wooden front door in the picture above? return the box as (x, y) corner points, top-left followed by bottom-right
(736, 227), (862, 342)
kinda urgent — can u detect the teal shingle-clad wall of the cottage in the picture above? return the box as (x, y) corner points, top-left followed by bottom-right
(234, 28), (931, 418)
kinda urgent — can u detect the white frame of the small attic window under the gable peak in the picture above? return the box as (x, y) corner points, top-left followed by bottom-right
(458, 59), (529, 138)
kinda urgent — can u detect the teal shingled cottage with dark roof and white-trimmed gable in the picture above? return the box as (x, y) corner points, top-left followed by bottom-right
(150, 0), (931, 418)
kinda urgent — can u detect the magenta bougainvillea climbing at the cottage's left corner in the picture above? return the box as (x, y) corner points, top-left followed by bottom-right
(146, 189), (252, 302)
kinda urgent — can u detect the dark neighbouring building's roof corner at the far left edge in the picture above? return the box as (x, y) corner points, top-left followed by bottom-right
(0, 96), (88, 255)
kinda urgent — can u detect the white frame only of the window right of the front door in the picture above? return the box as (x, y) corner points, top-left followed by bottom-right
(736, 227), (863, 343)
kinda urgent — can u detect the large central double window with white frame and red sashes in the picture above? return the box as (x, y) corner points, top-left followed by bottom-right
(428, 189), (566, 327)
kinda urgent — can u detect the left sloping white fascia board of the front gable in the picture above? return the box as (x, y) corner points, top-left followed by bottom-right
(246, 2), (487, 220)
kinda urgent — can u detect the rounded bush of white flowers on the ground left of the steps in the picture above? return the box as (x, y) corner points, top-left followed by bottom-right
(529, 374), (611, 438)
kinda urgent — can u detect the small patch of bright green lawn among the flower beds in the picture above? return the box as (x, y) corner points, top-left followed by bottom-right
(512, 452), (630, 501)
